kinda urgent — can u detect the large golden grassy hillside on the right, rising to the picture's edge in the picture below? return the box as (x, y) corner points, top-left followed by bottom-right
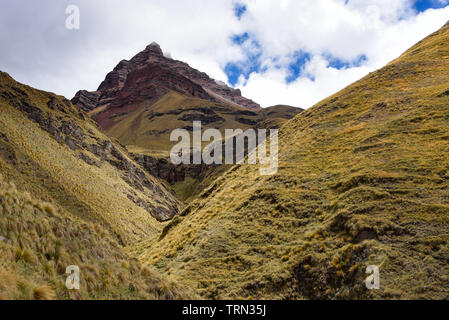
(138, 21), (449, 299)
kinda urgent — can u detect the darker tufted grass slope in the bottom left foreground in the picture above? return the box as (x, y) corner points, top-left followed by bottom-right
(0, 176), (194, 300)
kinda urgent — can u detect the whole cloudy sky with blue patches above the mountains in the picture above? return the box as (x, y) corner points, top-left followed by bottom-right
(0, 0), (449, 108)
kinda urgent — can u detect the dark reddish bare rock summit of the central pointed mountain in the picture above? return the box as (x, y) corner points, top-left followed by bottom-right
(72, 43), (261, 127)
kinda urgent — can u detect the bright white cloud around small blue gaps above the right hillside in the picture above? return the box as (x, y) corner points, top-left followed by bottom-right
(233, 0), (449, 107)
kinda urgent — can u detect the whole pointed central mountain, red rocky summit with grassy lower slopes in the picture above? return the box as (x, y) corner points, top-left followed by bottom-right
(72, 43), (303, 201)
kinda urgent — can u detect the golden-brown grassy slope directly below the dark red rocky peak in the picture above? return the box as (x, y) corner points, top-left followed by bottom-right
(104, 92), (302, 202)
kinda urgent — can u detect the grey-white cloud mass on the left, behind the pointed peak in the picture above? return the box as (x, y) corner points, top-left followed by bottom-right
(0, 0), (242, 97)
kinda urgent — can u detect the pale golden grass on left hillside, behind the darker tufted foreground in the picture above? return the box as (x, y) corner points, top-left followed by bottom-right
(0, 71), (176, 243)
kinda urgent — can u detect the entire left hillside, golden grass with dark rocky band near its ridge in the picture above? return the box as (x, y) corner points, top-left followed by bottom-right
(0, 73), (191, 299)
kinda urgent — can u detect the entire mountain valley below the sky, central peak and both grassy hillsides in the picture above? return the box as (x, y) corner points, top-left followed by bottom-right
(0, 23), (449, 300)
